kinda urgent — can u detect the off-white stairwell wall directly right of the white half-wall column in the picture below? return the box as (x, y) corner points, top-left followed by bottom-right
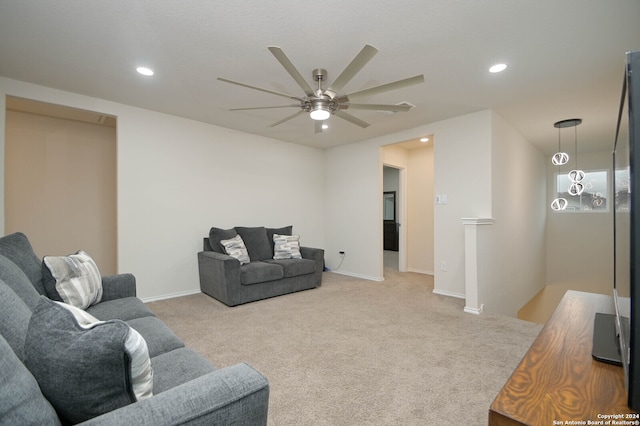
(480, 113), (548, 316)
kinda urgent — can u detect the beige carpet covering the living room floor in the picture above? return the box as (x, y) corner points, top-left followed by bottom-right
(149, 270), (542, 426)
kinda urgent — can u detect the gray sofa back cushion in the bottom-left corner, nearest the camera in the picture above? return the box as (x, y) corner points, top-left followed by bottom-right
(0, 336), (60, 425)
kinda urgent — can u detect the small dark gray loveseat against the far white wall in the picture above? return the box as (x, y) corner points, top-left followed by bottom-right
(198, 226), (324, 306)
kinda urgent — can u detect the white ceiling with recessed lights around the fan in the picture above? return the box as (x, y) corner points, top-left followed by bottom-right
(0, 0), (640, 154)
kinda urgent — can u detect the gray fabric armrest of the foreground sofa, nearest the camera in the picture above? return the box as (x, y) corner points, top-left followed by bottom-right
(82, 363), (269, 426)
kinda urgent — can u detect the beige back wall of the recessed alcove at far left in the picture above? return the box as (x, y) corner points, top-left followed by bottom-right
(5, 111), (117, 275)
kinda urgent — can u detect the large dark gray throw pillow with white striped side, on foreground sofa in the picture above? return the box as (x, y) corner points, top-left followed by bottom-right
(24, 297), (152, 423)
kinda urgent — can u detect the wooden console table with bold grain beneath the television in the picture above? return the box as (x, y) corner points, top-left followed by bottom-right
(489, 291), (640, 426)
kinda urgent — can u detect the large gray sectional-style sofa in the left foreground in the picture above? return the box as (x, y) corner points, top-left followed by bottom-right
(0, 233), (269, 426)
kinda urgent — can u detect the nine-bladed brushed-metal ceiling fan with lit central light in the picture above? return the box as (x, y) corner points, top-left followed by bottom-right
(218, 44), (424, 133)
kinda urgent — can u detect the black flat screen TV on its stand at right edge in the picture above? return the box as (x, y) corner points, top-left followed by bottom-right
(593, 51), (640, 412)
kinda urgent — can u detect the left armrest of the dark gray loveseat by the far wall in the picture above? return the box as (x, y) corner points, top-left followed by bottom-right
(198, 251), (240, 306)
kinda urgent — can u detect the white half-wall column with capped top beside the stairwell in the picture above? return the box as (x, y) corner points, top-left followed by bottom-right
(462, 217), (494, 315)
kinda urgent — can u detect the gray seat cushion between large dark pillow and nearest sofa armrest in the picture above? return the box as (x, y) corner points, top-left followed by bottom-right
(151, 348), (215, 395)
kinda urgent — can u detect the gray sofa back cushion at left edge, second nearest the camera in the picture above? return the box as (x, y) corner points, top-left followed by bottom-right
(0, 280), (31, 359)
